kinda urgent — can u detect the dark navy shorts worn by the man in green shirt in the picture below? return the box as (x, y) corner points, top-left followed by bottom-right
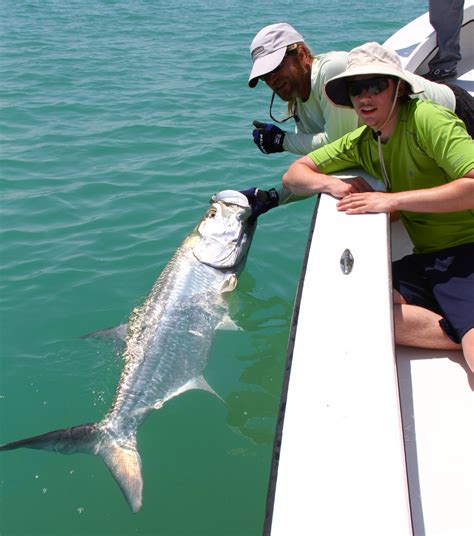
(392, 243), (474, 343)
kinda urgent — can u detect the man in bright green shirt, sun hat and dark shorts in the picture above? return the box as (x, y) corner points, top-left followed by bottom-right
(282, 43), (474, 372)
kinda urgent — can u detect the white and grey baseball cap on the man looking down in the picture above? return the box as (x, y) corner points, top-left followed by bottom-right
(249, 22), (304, 87)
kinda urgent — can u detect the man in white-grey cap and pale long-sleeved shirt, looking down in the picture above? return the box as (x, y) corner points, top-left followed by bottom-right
(248, 22), (358, 154)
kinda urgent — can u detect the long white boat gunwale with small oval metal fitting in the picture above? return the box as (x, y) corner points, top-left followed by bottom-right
(264, 196), (411, 536)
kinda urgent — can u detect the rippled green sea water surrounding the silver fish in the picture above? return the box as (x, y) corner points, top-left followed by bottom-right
(0, 0), (426, 536)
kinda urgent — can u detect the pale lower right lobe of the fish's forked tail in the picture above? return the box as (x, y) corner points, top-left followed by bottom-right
(100, 443), (143, 513)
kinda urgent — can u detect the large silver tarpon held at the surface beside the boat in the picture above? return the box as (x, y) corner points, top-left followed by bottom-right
(0, 190), (256, 512)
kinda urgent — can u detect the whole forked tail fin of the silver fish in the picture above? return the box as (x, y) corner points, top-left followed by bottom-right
(0, 424), (143, 512)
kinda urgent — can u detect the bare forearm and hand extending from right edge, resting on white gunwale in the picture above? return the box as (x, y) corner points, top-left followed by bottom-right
(337, 169), (474, 214)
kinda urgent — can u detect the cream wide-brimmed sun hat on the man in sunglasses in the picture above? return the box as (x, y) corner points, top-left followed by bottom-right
(324, 43), (424, 108)
